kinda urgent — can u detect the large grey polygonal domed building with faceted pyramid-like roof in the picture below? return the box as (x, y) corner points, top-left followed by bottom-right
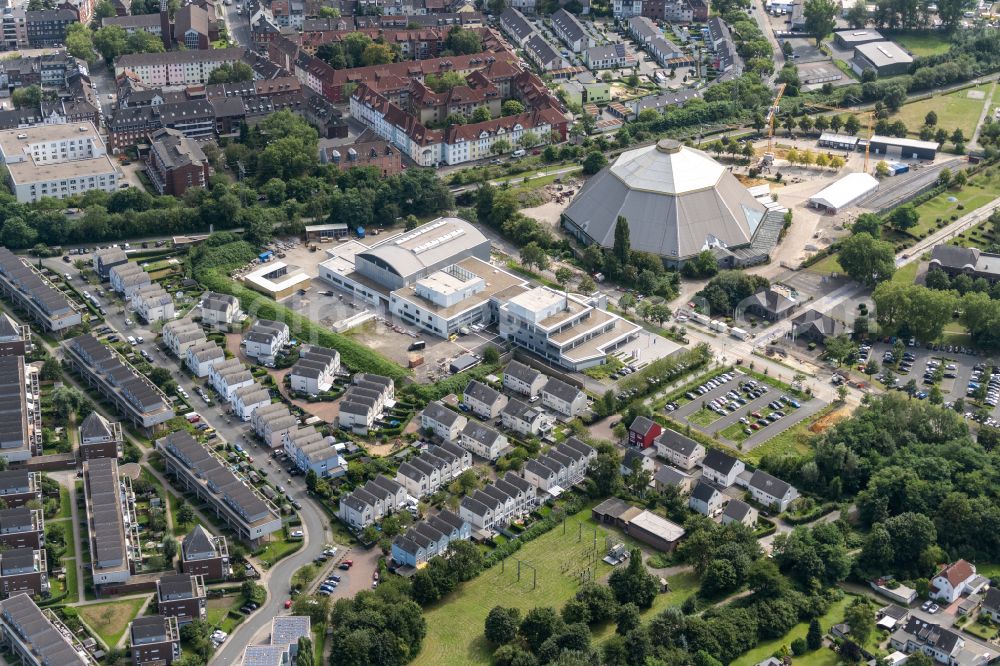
(563, 139), (785, 266)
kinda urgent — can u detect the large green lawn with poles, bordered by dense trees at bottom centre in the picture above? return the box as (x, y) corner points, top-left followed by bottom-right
(413, 507), (694, 666)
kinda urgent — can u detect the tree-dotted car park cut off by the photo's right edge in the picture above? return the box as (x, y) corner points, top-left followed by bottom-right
(855, 341), (1000, 425)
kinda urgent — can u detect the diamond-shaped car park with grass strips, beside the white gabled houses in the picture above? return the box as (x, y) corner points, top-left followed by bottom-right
(667, 368), (825, 450)
